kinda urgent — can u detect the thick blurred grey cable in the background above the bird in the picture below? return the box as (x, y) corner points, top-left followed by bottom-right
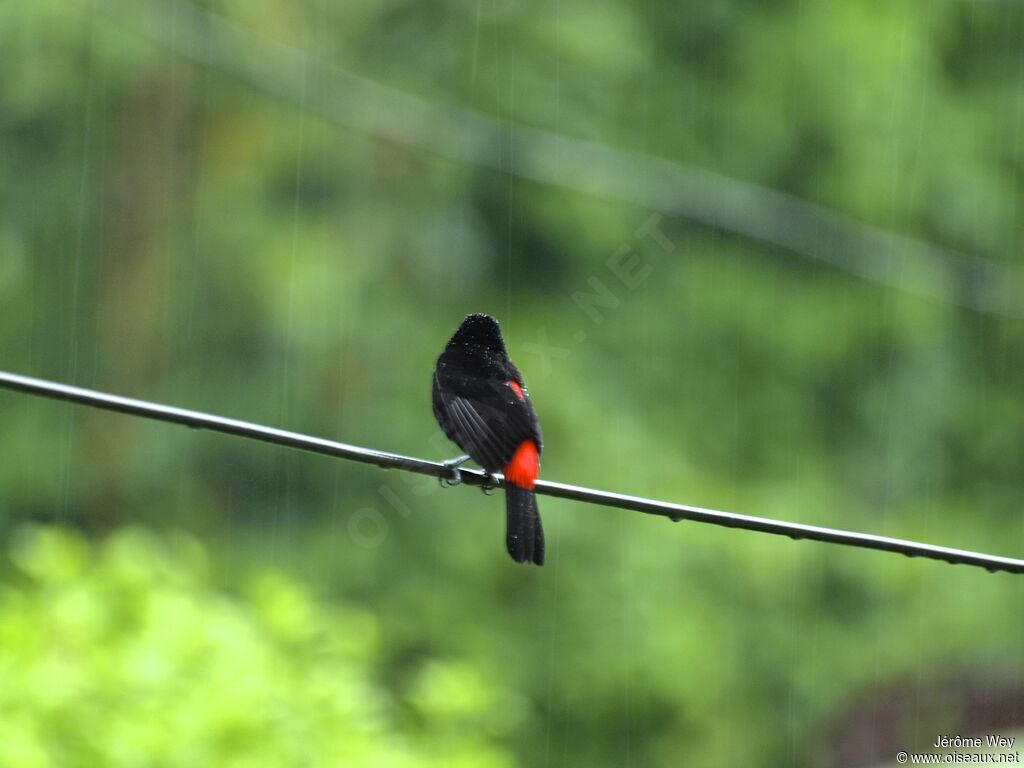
(80, 0), (1024, 318)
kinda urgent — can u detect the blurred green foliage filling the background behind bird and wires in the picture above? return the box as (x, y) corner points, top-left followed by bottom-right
(0, 0), (1024, 767)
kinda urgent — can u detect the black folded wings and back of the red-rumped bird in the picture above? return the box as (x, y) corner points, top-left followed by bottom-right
(435, 372), (541, 471)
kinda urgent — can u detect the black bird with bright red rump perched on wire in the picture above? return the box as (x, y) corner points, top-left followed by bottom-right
(431, 312), (544, 565)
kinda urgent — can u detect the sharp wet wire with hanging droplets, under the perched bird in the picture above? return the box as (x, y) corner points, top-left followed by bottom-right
(0, 372), (1024, 573)
